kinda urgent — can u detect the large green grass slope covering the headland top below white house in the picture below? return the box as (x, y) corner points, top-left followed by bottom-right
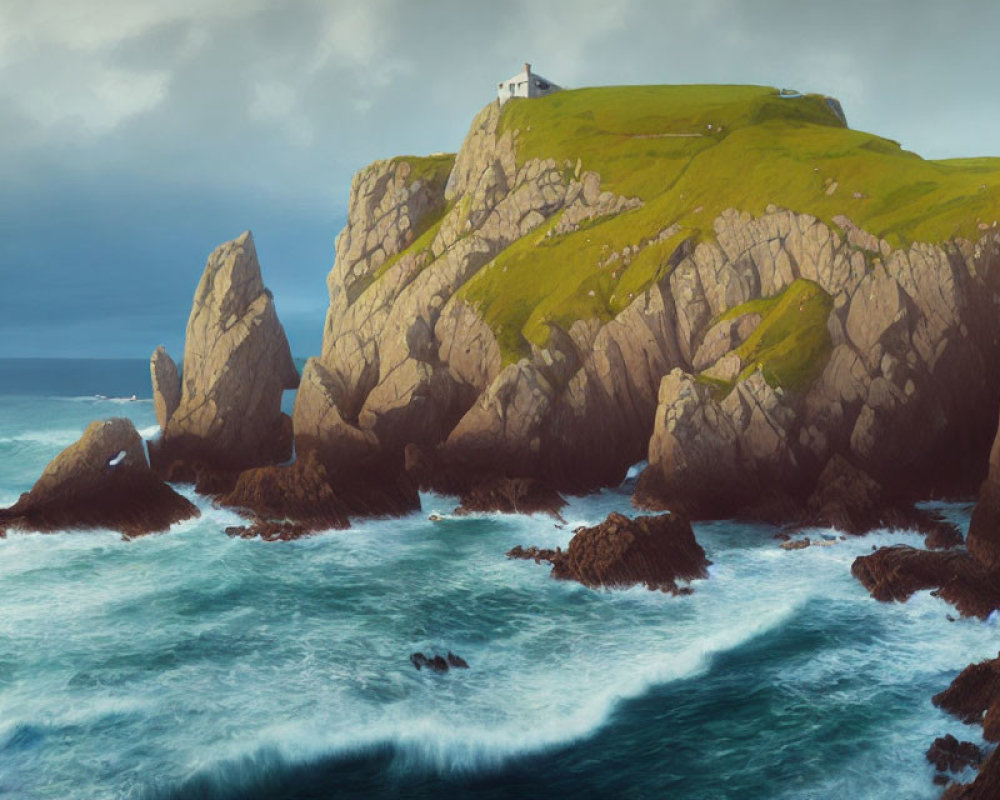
(372, 86), (1000, 362)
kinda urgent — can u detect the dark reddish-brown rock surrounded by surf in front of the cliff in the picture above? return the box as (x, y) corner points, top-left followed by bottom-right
(507, 513), (711, 593)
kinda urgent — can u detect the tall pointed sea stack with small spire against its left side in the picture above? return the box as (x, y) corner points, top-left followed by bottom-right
(150, 231), (298, 481)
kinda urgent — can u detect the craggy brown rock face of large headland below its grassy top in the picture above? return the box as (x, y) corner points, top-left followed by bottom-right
(294, 95), (1000, 506)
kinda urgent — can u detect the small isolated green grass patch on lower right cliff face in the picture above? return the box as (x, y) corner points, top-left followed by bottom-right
(727, 279), (833, 392)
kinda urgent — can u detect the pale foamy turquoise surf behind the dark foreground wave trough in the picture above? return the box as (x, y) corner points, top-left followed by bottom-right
(0, 438), (995, 798)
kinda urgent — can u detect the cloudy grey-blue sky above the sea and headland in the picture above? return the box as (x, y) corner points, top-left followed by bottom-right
(0, 0), (1000, 357)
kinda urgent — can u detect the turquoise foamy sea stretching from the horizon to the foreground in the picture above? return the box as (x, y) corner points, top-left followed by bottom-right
(0, 360), (1000, 800)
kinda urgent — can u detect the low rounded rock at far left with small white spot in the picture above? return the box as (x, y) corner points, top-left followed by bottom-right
(0, 418), (199, 536)
